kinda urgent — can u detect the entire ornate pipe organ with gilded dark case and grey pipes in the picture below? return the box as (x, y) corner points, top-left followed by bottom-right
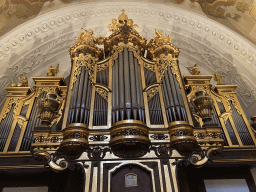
(0, 11), (256, 192)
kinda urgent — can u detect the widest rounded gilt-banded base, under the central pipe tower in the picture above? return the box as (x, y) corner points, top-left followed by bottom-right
(110, 120), (150, 158)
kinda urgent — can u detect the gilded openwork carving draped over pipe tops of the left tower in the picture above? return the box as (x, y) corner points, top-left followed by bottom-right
(71, 53), (97, 89)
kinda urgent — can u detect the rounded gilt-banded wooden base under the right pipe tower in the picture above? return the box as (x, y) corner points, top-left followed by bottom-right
(168, 121), (198, 155)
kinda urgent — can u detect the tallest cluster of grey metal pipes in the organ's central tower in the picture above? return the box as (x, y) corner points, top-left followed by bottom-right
(112, 48), (145, 123)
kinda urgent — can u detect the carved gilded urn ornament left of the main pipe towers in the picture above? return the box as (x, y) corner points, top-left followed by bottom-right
(37, 92), (61, 127)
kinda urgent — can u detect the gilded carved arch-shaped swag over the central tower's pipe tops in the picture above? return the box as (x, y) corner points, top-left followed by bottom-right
(109, 42), (143, 66)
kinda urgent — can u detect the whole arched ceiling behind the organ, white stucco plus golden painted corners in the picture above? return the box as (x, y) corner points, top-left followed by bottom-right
(0, 0), (256, 117)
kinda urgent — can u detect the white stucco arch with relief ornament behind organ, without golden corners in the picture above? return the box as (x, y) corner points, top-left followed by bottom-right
(0, 2), (256, 117)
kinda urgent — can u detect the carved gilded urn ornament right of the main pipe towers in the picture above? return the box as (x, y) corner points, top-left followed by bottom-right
(192, 91), (213, 126)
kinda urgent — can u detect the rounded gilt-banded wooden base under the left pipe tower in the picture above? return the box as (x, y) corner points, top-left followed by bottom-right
(60, 123), (89, 159)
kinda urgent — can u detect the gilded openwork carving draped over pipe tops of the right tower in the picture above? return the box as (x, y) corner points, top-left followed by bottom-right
(156, 54), (181, 87)
